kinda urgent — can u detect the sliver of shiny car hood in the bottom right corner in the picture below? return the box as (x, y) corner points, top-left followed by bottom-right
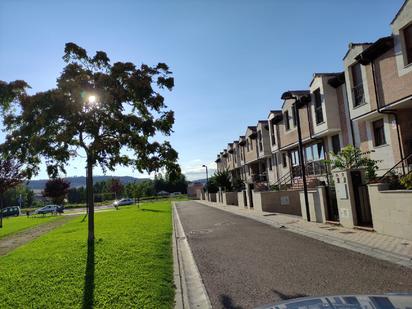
(256, 292), (412, 309)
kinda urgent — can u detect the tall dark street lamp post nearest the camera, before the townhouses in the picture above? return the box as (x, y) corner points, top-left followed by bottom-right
(282, 92), (310, 221)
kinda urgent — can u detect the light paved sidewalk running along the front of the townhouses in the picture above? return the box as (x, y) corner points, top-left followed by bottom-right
(196, 201), (412, 268)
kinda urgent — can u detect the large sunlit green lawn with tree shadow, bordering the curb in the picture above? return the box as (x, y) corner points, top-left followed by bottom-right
(0, 202), (174, 308)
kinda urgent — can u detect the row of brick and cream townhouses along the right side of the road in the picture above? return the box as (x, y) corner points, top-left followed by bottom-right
(216, 0), (412, 190)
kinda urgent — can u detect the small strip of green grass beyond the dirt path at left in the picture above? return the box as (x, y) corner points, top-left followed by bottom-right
(0, 215), (62, 238)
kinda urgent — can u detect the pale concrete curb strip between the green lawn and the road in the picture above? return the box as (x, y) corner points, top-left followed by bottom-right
(172, 202), (212, 309)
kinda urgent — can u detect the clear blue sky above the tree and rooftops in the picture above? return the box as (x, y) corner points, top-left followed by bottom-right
(0, 0), (403, 179)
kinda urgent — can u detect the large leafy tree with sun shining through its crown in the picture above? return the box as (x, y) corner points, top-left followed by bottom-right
(0, 43), (179, 241)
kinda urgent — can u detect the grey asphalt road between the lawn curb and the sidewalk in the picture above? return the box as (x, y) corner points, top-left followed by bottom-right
(177, 202), (412, 309)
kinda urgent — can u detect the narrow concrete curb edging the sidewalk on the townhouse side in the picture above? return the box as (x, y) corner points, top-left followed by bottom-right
(197, 201), (412, 268)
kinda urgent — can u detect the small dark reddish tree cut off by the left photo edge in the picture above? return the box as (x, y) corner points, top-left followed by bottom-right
(0, 158), (25, 228)
